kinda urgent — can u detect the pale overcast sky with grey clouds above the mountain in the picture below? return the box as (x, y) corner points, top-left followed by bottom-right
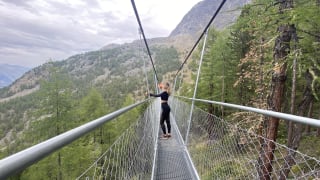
(0, 0), (201, 67)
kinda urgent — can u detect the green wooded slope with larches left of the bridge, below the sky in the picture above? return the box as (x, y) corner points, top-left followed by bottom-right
(0, 42), (180, 179)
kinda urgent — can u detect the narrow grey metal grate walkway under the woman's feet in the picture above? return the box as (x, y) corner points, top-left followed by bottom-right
(155, 116), (194, 180)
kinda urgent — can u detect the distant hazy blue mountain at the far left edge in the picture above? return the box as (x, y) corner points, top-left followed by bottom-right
(0, 64), (30, 88)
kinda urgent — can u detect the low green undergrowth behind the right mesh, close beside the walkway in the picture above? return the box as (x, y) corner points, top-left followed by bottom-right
(190, 132), (249, 180)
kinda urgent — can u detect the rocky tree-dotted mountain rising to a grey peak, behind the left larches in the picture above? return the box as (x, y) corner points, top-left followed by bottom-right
(0, 0), (248, 168)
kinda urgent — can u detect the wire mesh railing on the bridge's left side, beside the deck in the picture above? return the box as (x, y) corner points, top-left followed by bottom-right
(77, 100), (160, 180)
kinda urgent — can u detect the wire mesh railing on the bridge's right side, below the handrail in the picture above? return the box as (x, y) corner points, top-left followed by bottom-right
(171, 98), (320, 179)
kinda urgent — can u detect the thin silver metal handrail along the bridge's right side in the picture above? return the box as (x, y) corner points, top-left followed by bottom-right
(175, 96), (320, 128)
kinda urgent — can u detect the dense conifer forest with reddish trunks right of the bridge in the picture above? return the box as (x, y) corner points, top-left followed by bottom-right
(180, 0), (320, 174)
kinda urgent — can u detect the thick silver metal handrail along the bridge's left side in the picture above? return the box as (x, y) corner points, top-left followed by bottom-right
(0, 98), (150, 179)
